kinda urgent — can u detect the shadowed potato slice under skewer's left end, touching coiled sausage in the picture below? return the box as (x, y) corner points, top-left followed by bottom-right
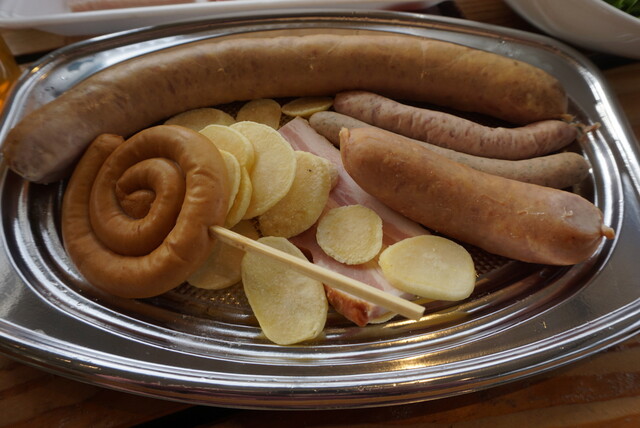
(187, 221), (260, 290)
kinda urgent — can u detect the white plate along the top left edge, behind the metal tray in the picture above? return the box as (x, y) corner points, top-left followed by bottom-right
(0, 0), (442, 36)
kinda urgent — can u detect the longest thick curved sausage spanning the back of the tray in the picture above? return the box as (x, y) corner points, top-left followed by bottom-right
(4, 34), (567, 183)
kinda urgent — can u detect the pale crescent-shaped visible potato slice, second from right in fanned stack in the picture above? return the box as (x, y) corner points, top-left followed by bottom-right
(231, 121), (296, 219)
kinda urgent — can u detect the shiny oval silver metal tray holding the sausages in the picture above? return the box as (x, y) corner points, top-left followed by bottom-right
(0, 12), (640, 409)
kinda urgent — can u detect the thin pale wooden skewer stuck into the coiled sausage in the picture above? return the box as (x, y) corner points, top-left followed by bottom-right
(209, 226), (424, 320)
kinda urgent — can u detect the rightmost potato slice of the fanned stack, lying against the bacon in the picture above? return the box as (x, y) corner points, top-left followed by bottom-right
(258, 151), (331, 238)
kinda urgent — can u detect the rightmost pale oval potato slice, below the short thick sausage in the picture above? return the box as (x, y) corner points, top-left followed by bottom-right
(378, 235), (476, 301)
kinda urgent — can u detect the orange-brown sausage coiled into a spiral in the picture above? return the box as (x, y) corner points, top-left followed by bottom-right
(61, 125), (229, 298)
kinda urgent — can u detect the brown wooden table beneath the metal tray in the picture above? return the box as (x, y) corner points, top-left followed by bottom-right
(0, 0), (640, 428)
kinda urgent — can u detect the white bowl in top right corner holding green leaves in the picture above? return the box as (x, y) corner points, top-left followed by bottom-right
(506, 0), (640, 59)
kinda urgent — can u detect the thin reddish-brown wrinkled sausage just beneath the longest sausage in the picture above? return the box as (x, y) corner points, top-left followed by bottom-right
(333, 91), (579, 160)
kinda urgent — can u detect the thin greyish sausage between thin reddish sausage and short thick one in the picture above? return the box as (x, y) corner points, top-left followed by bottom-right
(309, 111), (591, 189)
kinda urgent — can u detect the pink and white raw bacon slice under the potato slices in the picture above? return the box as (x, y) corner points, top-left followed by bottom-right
(280, 118), (427, 326)
